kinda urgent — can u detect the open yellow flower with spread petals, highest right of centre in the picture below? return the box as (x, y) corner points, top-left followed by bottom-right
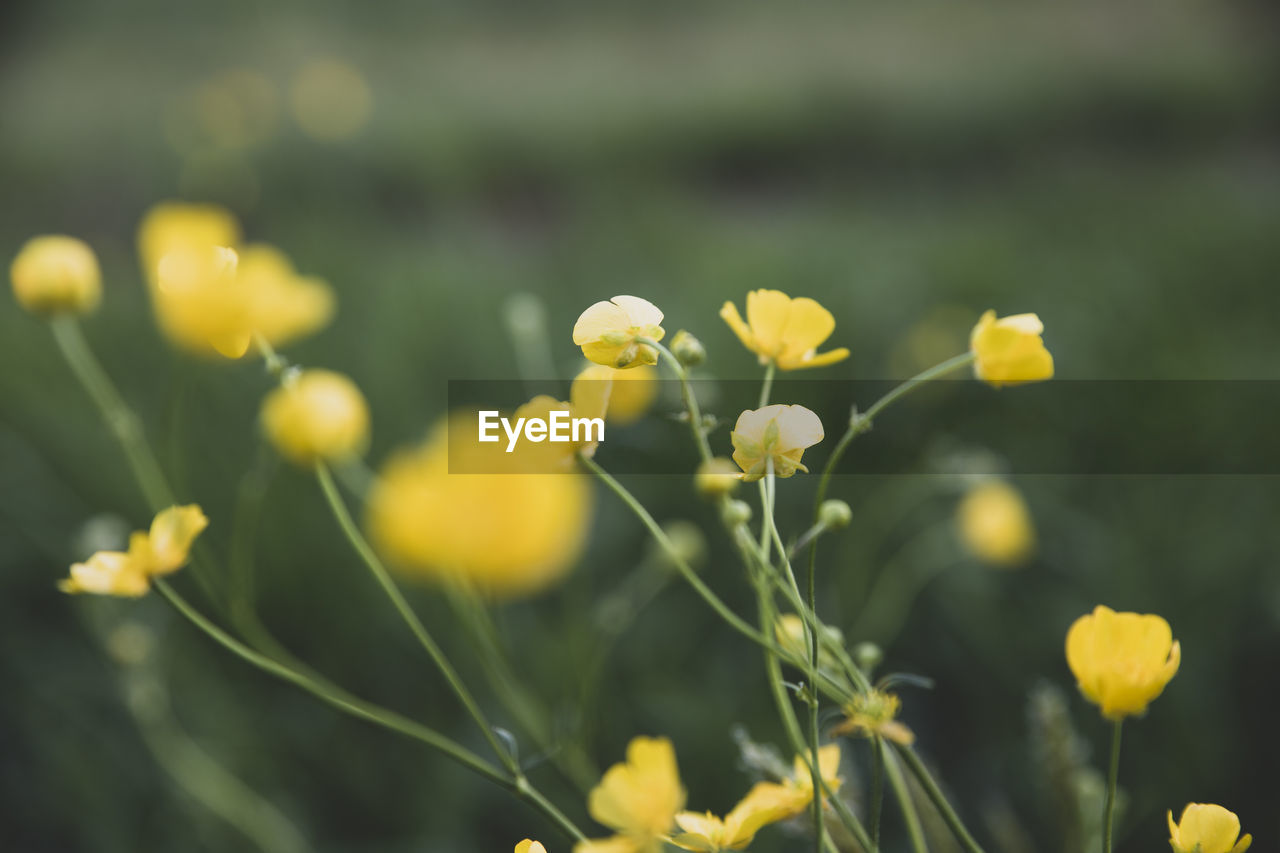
(721, 291), (849, 370)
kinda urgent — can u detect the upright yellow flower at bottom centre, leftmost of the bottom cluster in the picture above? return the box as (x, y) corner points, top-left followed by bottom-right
(573, 738), (685, 853)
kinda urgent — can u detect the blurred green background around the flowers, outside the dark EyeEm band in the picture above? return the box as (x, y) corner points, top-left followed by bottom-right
(0, 0), (1280, 853)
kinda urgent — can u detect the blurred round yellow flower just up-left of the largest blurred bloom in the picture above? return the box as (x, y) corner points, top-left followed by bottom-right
(262, 370), (369, 465)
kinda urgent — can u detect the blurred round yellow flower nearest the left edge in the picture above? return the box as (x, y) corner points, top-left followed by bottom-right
(9, 234), (102, 314)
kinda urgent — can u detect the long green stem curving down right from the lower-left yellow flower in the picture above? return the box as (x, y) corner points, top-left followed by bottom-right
(152, 578), (585, 841)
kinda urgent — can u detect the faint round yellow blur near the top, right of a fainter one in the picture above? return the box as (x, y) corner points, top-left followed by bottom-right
(289, 59), (374, 142)
